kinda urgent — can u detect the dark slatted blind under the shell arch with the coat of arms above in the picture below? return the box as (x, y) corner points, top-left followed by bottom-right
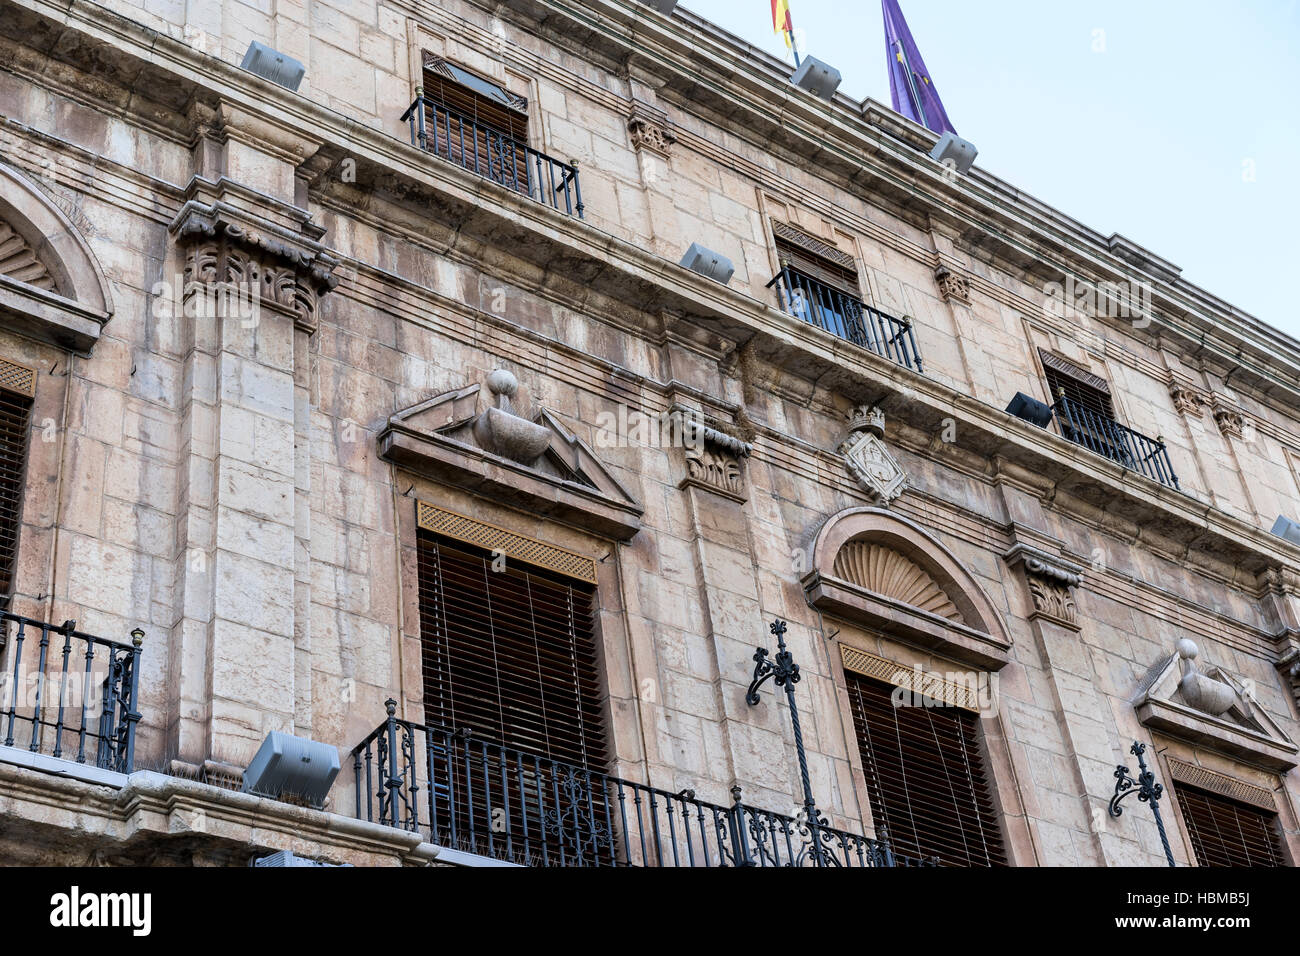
(846, 671), (1006, 866)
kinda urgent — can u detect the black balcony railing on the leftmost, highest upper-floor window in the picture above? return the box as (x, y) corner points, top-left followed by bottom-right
(402, 90), (582, 219)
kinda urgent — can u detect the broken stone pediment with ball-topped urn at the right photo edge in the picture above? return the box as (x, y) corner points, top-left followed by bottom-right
(1134, 639), (1300, 773)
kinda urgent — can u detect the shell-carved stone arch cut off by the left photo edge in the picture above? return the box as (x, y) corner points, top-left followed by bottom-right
(0, 163), (113, 352)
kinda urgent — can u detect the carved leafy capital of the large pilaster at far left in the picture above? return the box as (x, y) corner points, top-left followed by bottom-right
(172, 202), (338, 333)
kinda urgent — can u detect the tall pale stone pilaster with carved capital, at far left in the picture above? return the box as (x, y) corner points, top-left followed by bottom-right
(169, 100), (337, 766)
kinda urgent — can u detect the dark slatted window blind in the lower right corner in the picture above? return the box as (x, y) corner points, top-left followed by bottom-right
(1178, 783), (1286, 866)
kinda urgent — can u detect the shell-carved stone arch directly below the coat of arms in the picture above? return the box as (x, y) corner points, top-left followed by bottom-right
(803, 507), (1011, 670)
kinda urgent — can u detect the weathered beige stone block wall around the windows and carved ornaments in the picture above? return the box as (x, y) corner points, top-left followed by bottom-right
(0, 1), (1300, 865)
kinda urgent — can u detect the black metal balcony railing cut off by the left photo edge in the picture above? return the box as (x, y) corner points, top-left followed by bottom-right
(0, 611), (144, 774)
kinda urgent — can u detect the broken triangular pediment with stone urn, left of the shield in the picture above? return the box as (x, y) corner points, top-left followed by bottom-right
(378, 385), (642, 541)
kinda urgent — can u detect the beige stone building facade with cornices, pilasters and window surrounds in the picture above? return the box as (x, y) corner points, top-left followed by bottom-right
(0, 0), (1300, 866)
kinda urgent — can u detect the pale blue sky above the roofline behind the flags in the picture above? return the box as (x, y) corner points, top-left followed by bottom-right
(683, 0), (1300, 338)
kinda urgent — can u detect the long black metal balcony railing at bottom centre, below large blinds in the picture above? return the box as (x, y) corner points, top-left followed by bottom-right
(352, 700), (931, 866)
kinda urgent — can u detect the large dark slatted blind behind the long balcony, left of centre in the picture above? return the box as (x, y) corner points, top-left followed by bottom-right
(419, 531), (607, 771)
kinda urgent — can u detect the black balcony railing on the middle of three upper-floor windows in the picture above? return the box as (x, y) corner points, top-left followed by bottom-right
(767, 264), (922, 372)
